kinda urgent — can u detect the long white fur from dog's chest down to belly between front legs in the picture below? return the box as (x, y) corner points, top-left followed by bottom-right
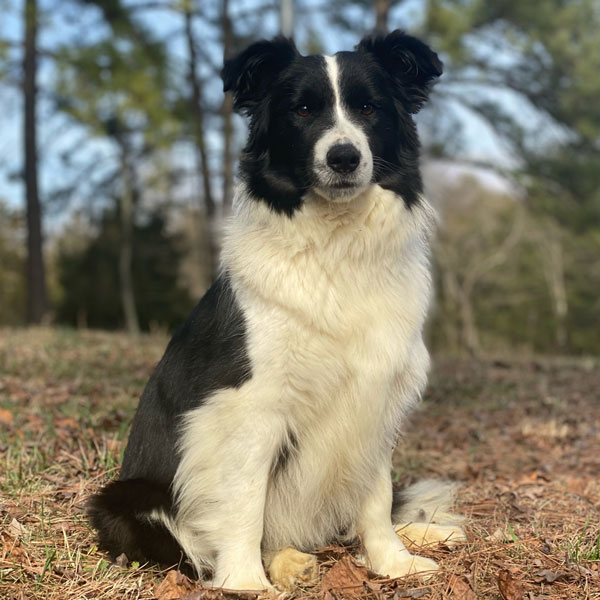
(218, 186), (433, 547)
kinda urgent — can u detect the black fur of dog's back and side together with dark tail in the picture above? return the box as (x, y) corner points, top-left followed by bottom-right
(88, 276), (251, 574)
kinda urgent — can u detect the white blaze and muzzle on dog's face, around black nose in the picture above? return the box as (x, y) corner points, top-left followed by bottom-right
(313, 56), (373, 200)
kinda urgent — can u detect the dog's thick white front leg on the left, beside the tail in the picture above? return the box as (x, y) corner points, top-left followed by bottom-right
(176, 400), (281, 590)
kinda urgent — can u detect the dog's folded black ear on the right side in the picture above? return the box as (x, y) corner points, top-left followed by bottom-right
(358, 29), (443, 114)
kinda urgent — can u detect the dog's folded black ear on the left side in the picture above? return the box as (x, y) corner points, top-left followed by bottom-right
(221, 36), (298, 114)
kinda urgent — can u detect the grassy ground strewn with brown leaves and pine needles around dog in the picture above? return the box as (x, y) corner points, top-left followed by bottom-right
(0, 329), (600, 600)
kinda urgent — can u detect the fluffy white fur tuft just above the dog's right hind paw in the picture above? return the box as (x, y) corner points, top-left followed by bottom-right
(392, 479), (464, 525)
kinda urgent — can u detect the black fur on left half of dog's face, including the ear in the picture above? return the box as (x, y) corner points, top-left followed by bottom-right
(222, 44), (333, 216)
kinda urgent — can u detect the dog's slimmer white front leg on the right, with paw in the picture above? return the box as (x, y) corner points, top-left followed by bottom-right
(357, 464), (438, 577)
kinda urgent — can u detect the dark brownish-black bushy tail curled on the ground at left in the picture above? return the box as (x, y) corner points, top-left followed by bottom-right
(88, 479), (189, 571)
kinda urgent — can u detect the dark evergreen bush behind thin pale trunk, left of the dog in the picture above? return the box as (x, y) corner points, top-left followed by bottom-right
(56, 209), (194, 330)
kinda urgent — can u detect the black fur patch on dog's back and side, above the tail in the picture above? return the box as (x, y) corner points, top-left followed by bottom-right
(119, 276), (251, 486)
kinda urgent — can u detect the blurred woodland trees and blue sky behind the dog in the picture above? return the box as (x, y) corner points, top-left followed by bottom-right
(0, 0), (600, 354)
